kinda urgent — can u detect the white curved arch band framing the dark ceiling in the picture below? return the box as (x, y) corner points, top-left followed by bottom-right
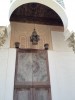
(9, 0), (68, 31)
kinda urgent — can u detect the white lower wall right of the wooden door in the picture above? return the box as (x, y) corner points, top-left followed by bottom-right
(48, 51), (75, 100)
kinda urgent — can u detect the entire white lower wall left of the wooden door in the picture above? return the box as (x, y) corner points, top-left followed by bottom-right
(0, 49), (16, 100)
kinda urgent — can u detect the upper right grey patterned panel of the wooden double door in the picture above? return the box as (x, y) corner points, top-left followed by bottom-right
(32, 51), (48, 82)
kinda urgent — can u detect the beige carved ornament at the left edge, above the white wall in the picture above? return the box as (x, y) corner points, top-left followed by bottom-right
(0, 26), (7, 47)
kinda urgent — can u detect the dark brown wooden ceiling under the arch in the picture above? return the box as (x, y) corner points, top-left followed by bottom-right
(10, 3), (63, 26)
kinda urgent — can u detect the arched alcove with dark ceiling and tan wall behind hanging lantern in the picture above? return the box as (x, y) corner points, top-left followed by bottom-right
(10, 3), (64, 49)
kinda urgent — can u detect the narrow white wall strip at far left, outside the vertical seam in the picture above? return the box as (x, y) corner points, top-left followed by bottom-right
(0, 49), (8, 100)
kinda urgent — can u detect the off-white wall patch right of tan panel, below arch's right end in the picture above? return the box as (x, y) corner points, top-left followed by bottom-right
(51, 31), (72, 52)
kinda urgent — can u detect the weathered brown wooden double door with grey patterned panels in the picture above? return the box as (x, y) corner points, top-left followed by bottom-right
(14, 49), (51, 100)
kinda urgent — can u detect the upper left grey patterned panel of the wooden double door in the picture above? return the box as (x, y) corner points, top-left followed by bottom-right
(16, 52), (32, 82)
